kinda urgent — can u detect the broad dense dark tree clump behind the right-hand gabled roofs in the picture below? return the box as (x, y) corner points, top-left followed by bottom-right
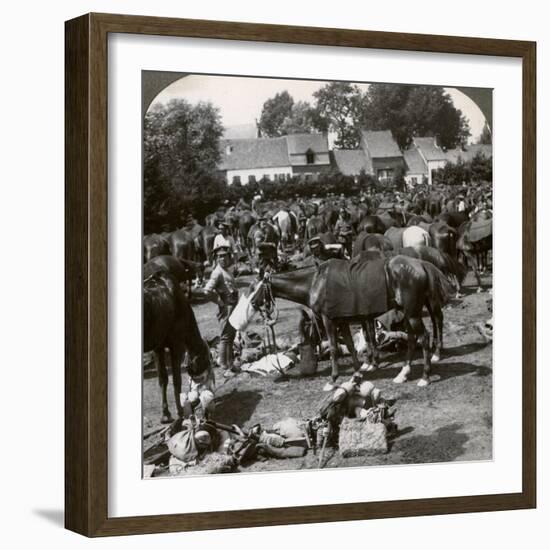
(363, 84), (470, 149)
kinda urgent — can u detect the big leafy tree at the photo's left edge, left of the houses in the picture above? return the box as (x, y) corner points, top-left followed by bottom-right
(143, 99), (227, 232)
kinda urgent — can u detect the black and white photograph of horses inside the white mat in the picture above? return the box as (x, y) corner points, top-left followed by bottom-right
(142, 71), (493, 478)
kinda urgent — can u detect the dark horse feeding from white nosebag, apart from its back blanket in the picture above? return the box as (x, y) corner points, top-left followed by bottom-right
(254, 253), (453, 390)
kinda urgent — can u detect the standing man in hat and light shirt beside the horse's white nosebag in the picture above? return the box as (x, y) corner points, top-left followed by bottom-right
(195, 246), (239, 378)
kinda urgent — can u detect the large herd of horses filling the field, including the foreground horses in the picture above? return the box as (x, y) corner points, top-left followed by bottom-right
(143, 185), (492, 421)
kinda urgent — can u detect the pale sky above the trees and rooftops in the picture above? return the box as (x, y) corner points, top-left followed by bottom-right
(152, 75), (485, 142)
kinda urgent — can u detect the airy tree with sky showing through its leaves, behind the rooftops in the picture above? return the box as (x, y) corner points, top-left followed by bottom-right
(313, 82), (365, 149)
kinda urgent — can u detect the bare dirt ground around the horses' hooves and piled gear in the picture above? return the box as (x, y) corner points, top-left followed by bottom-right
(143, 274), (493, 472)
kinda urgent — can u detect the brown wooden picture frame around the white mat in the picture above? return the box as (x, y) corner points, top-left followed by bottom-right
(65, 14), (536, 536)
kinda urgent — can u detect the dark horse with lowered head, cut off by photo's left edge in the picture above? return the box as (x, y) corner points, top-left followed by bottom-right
(143, 270), (211, 423)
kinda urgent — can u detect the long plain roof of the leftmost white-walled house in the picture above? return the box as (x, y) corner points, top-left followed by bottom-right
(218, 137), (290, 170)
